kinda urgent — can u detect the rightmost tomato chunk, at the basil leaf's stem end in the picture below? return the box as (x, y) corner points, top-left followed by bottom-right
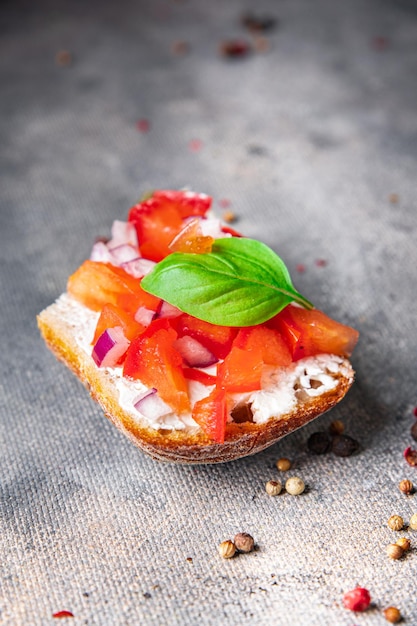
(268, 305), (359, 361)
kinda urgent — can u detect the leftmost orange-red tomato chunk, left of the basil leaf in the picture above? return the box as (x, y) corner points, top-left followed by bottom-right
(67, 260), (161, 313)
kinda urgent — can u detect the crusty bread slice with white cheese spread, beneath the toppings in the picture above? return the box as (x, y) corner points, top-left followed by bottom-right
(38, 294), (354, 464)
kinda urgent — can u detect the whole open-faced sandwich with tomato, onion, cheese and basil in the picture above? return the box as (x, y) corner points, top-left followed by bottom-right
(38, 191), (358, 463)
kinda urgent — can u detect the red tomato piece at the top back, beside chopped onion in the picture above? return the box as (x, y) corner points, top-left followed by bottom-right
(128, 197), (183, 262)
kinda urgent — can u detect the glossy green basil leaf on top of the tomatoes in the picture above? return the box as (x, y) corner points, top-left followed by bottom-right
(141, 237), (312, 326)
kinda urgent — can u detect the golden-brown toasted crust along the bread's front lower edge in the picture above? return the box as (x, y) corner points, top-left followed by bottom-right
(37, 298), (353, 464)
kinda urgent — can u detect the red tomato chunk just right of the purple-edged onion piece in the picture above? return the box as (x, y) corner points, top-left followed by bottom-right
(123, 319), (190, 414)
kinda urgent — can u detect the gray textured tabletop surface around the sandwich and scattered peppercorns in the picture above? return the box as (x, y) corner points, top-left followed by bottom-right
(0, 0), (417, 626)
